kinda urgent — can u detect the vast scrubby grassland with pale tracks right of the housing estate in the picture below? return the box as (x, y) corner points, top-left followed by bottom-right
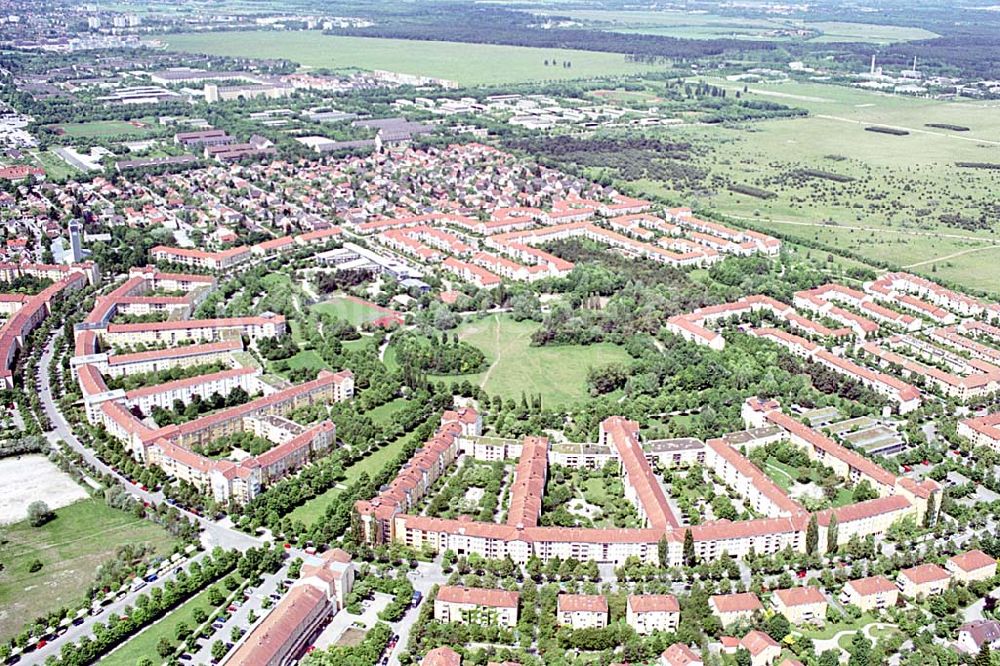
(633, 79), (1000, 292)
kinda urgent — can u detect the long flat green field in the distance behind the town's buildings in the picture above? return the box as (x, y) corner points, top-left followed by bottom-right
(162, 31), (659, 85)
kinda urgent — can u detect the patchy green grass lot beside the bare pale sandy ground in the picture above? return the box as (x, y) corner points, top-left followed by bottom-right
(0, 499), (174, 640)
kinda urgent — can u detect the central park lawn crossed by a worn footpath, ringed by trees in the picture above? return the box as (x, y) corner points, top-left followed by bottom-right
(430, 315), (629, 407)
